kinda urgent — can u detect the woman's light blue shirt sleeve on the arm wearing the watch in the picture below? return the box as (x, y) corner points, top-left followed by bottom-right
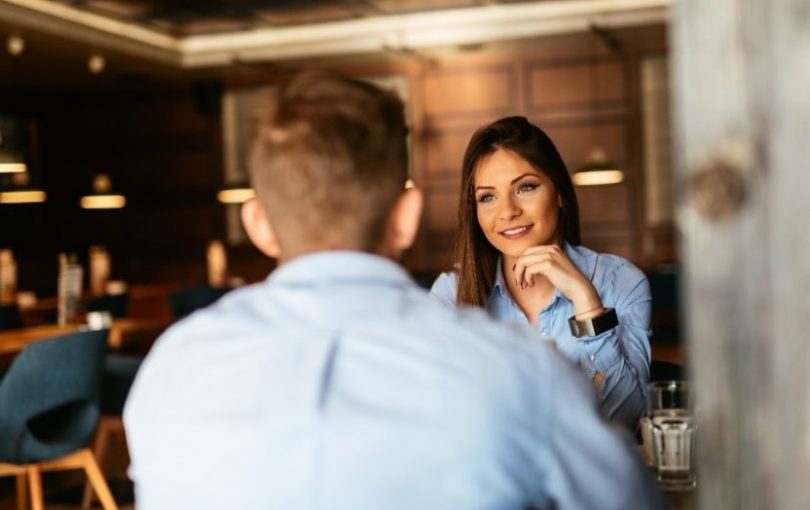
(579, 264), (651, 431)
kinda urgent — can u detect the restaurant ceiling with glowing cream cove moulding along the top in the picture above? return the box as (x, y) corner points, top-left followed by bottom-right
(0, 0), (672, 89)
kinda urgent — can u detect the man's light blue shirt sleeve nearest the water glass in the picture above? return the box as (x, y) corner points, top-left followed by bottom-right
(533, 350), (669, 510)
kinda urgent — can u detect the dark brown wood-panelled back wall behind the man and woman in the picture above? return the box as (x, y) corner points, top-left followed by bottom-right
(0, 23), (674, 293)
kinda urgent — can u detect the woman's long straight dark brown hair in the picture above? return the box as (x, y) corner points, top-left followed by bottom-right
(455, 117), (580, 307)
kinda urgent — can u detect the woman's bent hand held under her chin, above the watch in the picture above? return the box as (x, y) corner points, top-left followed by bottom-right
(514, 245), (603, 319)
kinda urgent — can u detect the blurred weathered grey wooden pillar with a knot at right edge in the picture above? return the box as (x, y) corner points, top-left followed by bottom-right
(672, 0), (810, 510)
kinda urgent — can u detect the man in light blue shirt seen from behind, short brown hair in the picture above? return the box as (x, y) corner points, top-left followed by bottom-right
(125, 74), (660, 510)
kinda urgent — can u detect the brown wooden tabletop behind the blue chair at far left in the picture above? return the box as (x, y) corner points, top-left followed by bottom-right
(0, 318), (170, 356)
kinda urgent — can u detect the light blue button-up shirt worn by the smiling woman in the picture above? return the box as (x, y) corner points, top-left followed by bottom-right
(431, 244), (651, 431)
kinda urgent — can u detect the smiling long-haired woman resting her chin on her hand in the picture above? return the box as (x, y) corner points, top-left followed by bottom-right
(431, 117), (650, 431)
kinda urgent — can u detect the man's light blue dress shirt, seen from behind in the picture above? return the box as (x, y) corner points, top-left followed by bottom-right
(124, 252), (662, 510)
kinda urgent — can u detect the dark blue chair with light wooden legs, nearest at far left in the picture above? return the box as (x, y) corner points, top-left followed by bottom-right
(0, 330), (117, 510)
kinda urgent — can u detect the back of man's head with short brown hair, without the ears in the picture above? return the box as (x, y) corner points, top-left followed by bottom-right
(250, 73), (408, 254)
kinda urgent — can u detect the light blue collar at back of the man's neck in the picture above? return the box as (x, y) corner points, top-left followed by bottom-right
(266, 250), (411, 285)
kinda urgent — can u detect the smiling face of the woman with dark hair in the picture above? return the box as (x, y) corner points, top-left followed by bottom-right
(473, 149), (560, 257)
